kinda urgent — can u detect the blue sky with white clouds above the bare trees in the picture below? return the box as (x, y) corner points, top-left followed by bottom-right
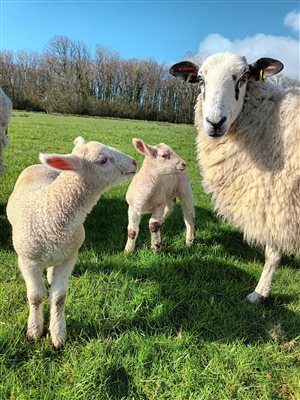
(0, 0), (299, 78)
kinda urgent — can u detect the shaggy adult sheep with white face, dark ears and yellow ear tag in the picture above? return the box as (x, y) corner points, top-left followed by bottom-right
(170, 53), (300, 302)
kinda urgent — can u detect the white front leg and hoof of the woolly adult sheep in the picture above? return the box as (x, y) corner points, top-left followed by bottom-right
(247, 245), (281, 303)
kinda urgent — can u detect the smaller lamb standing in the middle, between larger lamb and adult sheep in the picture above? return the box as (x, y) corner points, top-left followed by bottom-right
(125, 139), (195, 252)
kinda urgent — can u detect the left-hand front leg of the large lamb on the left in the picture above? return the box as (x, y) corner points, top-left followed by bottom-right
(18, 258), (46, 340)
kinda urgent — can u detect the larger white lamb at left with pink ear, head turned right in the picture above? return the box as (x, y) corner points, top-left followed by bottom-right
(7, 137), (136, 348)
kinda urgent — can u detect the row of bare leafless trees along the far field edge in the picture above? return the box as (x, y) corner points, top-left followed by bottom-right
(0, 36), (199, 123)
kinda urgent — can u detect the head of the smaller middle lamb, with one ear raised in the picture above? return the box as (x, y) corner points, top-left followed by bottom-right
(132, 138), (186, 175)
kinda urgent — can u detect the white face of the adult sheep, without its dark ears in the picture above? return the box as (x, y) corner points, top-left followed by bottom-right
(198, 54), (249, 138)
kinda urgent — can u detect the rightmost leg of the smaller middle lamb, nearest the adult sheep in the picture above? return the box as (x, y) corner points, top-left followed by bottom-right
(178, 179), (195, 246)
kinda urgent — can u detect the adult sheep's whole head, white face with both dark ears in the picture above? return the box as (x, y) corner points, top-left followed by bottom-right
(170, 53), (283, 138)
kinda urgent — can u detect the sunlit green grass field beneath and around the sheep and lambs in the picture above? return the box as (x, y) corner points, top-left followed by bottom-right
(0, 112), (300, 400)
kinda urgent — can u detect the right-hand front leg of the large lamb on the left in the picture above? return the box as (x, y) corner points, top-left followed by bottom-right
(49, 254), (77, 348)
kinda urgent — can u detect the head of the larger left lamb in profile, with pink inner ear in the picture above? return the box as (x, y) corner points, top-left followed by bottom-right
(40, 137), (137, 189)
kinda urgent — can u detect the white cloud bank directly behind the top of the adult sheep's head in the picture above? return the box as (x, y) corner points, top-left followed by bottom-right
(197, 33), (300, 79)
